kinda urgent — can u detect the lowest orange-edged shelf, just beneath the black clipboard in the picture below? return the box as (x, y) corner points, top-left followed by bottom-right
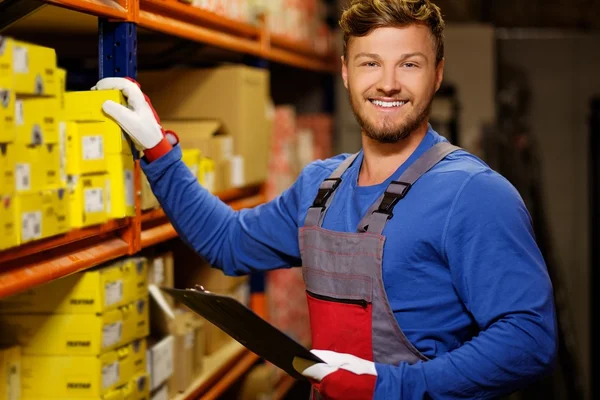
(175, 340), (259, 400)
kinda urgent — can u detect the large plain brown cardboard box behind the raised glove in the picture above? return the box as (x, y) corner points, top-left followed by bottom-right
(138, 65), (271, 184)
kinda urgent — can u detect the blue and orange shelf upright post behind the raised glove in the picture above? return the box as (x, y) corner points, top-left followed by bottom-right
(98, 18), (142, 254)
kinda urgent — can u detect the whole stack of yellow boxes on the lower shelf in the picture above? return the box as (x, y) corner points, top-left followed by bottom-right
(0, 258), (150, 399)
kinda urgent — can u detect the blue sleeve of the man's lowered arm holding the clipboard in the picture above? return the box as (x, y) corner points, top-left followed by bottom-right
(375, 171), (557, 399)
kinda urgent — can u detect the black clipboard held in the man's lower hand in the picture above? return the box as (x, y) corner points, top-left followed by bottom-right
(161, 287), (323, 380)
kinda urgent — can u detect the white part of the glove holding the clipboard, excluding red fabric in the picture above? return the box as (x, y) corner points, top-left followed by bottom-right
(302, 350), (377, 382)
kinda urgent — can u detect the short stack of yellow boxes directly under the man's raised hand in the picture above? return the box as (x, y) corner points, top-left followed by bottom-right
(65, 90), (135, 227)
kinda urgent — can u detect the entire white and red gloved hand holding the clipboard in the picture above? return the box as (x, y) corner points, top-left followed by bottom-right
(302, 350), (377, 400)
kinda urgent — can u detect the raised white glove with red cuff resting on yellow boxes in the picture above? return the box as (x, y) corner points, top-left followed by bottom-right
(92, 78), (179, 161)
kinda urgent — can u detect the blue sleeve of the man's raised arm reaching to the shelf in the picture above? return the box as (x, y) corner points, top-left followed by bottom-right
(141, 146), (302, 275)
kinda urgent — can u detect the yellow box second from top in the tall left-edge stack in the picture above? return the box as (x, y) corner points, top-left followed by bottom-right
(15, 97), (60, 144)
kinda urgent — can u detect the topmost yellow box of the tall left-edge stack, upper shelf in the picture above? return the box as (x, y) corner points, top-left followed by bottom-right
(0, 36), (58, 96)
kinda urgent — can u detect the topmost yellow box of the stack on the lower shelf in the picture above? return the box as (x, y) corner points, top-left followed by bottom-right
(0, 257), (148, 314)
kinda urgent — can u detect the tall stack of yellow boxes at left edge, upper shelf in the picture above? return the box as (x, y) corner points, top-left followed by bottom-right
(0, 36), (70, 250)
